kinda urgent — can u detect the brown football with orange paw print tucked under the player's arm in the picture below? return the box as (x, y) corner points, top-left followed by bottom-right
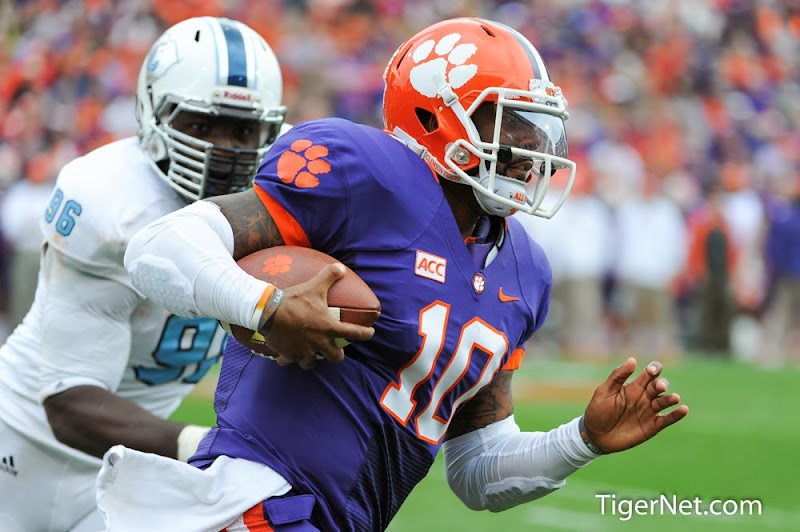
(220, 246), (381, 357)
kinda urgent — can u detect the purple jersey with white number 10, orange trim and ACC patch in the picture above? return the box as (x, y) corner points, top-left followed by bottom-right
(193, 119), (551, 531)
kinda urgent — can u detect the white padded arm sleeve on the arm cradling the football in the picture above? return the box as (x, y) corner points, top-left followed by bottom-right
(125, 201), (268, 330)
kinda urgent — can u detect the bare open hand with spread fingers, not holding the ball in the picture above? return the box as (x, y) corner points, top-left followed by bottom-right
(584, 357), (689, 453)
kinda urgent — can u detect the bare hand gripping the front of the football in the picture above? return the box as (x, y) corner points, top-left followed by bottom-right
(265, 264), (375, 369)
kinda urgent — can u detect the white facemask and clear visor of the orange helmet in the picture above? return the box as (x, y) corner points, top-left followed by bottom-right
(444, 80), (576, 218)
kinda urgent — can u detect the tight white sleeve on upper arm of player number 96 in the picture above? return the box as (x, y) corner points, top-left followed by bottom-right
(39, 248), (141, 401)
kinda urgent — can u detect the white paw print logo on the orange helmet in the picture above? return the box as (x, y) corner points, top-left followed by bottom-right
(409, 33), (478, 98)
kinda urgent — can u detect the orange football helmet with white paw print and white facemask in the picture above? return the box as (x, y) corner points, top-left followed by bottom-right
(383, 18), (576, 218)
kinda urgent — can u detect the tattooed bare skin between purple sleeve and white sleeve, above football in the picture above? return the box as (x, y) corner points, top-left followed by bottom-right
(212, 190), (284, 260)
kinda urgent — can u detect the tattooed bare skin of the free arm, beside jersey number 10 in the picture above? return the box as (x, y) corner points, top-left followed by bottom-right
(447, 371), (514, 439)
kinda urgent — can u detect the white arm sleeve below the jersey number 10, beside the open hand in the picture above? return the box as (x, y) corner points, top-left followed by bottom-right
(442, 416), (598, 512)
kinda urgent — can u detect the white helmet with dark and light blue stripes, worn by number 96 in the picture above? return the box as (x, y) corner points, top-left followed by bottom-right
(136, 17), (286, 201)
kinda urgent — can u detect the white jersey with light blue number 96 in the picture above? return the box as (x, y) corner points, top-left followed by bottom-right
(0, 137), (224, 462)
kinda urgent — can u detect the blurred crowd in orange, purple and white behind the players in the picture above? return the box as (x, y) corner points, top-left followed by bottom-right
(0, 0), (800, 366)
